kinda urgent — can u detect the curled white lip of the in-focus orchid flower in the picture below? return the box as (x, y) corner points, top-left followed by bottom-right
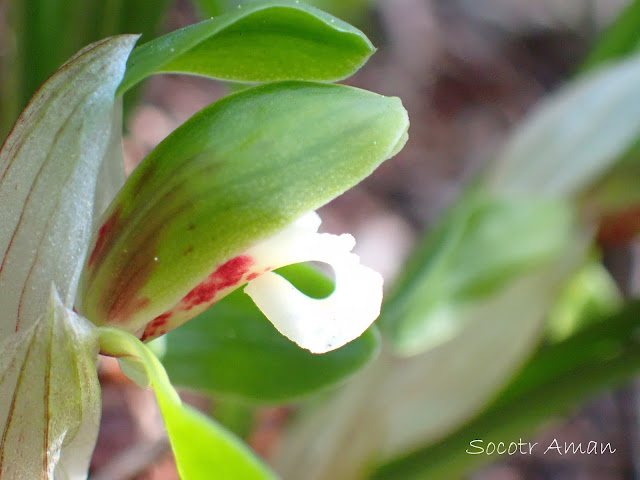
(244, 212), (383, 353)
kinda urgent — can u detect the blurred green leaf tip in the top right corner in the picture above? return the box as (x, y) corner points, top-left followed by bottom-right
(580, 0), (640, 72)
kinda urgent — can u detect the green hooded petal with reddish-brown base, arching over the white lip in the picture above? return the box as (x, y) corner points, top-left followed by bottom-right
(80, 82), (408, 331)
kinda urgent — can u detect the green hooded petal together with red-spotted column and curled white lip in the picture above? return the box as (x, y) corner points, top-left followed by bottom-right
(78, 82), (408, 353)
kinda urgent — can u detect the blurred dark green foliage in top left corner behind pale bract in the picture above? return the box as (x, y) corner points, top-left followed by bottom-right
(0, 0), (169, 138)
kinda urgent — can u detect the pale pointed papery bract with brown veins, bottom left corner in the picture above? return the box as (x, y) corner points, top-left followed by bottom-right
(0, 290), (101, 480)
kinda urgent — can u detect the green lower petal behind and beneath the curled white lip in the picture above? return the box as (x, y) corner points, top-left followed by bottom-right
(156, 265), (379, 403)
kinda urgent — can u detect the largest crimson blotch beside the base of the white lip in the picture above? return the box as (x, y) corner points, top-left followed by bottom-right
(180, 255), (253, 310)
